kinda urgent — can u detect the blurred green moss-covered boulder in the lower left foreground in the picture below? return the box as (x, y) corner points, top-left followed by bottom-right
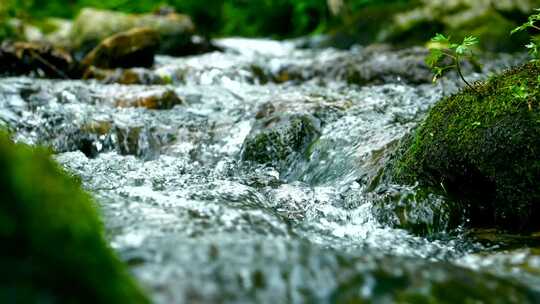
(0, 133), (148, 303)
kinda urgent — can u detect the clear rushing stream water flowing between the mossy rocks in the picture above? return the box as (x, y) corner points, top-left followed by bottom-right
(0, 39), (540, 303)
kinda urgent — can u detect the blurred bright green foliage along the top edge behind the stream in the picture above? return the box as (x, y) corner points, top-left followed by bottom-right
(2, 0), (410, 37)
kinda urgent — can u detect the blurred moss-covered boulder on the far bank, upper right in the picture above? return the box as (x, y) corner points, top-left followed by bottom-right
(381, 0), (540, 51)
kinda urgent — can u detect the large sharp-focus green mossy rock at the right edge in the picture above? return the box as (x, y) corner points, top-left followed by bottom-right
(391, 63), (540, 230)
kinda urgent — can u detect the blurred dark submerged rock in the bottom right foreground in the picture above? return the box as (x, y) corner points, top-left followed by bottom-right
(332, 257), (540, 304)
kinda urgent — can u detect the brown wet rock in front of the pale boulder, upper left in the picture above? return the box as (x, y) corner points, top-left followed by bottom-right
(82, 28), (159, 69)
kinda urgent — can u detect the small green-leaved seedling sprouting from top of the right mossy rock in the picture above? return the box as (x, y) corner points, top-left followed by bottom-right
(426, 34), (479, 90)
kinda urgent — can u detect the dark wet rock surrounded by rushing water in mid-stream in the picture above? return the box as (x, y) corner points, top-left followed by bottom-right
(242, 109), (320, 166)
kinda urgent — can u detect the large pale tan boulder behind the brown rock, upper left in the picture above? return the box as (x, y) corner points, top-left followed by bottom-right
(70, 8), (195, 55)
